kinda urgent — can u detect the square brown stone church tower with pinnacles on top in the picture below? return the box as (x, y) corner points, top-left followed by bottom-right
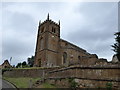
(34, 14), (60, 67)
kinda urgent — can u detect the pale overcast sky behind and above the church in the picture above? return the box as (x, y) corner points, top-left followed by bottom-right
(0, 2), (118, 65)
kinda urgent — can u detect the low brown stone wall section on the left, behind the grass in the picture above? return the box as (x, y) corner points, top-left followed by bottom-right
(3, 68), (56, 77)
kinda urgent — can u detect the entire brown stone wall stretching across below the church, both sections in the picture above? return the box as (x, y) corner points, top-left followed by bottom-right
(3, 64), (120, 88)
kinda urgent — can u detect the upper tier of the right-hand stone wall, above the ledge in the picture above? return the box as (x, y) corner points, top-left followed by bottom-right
(48, 66), (120, 80)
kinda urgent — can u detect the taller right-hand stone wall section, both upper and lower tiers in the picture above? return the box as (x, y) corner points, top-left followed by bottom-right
(46, 65), (120, 88)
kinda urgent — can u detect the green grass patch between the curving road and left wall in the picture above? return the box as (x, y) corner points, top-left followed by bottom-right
(3, 77), (40, 88)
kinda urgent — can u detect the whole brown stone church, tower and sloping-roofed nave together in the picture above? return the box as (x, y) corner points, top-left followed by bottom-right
(34, 14), (99, 67)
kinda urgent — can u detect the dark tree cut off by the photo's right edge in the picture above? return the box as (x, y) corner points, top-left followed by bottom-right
(112, 32), (120, 61)
